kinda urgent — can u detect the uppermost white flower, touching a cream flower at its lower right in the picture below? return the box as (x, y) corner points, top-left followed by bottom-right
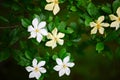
(28, 18), (48, 42)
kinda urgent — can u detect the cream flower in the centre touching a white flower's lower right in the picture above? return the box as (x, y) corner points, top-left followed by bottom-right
(45, 28), (65, 49)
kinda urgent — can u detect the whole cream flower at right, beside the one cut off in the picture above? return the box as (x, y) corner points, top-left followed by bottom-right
(90, 16), (109, 34)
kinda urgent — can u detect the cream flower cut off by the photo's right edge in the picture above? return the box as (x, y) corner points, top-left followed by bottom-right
(109, 7), (120, 30)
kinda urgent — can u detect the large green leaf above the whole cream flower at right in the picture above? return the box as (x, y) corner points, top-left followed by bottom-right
(87, 3), (99, 18)
